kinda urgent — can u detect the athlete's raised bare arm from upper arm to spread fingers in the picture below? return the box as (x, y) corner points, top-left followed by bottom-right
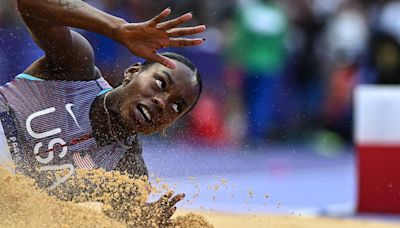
(18, 0), (205, 72)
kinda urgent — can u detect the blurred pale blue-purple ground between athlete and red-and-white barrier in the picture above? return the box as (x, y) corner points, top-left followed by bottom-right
(144, 141), (357, 216)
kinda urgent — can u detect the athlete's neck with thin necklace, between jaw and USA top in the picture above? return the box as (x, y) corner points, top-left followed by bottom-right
(89, 90), (132, 145)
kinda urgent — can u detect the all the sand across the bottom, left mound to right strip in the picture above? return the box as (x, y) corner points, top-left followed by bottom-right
(0, 168), (400, 228)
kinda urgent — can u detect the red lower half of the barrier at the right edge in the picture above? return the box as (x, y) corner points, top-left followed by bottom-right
(357, 145), (400, 214)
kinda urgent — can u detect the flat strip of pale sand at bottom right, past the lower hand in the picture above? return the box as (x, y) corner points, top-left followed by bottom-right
(176, 210), (400, 228)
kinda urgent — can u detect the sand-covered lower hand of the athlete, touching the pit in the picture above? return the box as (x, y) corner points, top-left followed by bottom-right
(147, 191), (185, 225)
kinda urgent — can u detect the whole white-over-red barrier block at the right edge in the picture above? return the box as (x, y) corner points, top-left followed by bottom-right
(354, 86), (400, 214)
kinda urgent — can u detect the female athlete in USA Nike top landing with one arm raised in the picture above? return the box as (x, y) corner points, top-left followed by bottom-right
(0, 0), (206, 224)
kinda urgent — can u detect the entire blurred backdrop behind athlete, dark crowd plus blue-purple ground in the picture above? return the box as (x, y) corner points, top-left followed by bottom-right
(0, 0), (400, 221)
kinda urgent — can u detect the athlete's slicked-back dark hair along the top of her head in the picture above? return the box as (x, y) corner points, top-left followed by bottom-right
(142, 52), (203, 113)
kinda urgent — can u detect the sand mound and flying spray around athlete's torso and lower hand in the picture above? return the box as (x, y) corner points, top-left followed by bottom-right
(0, 168), (213, 227)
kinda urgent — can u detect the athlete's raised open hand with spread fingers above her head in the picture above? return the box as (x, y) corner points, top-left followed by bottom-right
(117, 8), (206, 68)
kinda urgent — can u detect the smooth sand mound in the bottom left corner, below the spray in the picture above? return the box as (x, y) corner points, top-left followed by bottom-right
(0, 169), (123, 227)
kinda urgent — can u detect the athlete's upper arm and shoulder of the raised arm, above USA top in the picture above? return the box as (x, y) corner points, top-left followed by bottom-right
(18, 9), (96, 80)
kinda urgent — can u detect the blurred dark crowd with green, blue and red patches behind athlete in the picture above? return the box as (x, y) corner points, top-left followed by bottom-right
(0, 0), (400, 145)
